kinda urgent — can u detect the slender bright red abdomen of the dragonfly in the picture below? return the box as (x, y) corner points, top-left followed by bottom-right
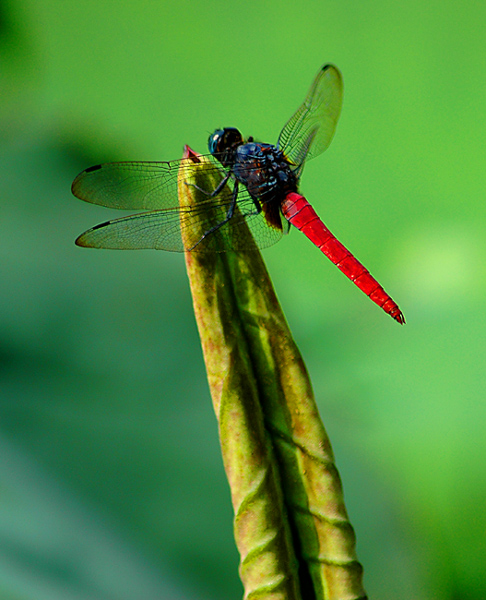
(281, 192), (405, 324)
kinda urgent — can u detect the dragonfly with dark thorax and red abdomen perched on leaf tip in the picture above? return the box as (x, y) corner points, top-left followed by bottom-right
(72, 64), (405, 324)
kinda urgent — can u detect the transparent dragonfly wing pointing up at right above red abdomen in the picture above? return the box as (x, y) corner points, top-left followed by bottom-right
(277, 65), (343, 176)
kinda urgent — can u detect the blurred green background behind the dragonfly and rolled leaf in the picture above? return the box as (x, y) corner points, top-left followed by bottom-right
(0, 0), (486, 600)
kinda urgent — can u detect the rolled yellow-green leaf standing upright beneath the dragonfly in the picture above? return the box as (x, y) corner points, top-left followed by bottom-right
(179, 148), (366, 600)
